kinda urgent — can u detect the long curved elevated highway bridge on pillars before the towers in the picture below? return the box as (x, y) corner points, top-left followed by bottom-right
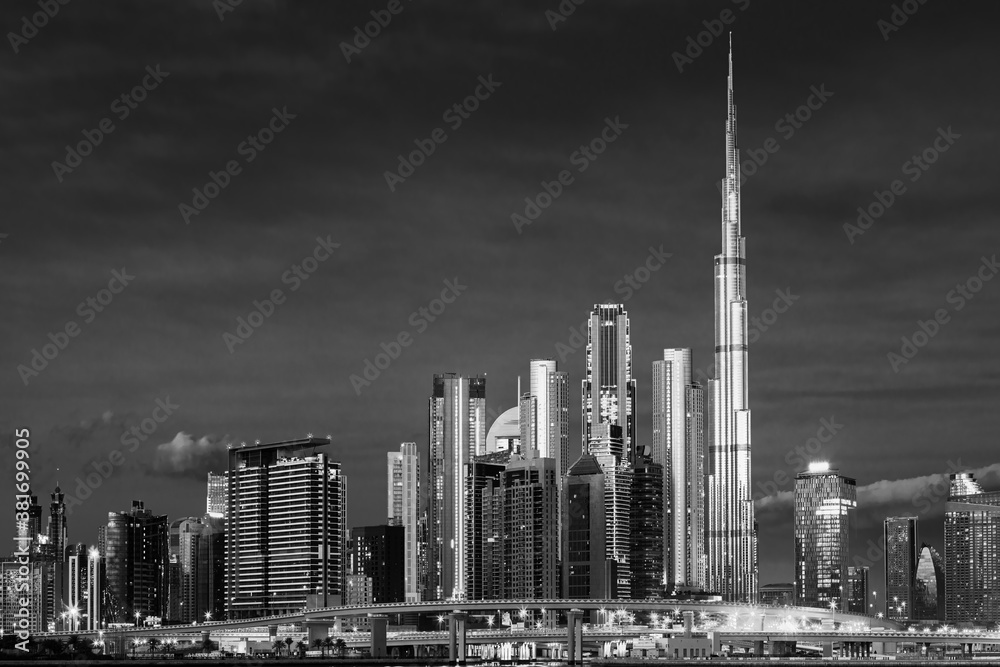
(48, 599), (984, 664)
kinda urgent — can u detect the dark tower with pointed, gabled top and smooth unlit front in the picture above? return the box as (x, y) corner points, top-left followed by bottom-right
(560, 451), (618, 600)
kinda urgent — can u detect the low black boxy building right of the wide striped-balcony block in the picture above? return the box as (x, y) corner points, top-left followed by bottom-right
(350, 526), (406, 604)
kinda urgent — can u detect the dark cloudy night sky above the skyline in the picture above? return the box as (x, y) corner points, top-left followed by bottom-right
(0, 0), (1000, 604)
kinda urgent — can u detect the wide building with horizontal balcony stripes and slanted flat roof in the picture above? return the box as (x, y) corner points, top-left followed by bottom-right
(226, 437), (347, 619)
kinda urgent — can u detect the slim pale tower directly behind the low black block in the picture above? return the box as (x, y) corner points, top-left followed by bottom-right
(386, 442), (421, 602)
